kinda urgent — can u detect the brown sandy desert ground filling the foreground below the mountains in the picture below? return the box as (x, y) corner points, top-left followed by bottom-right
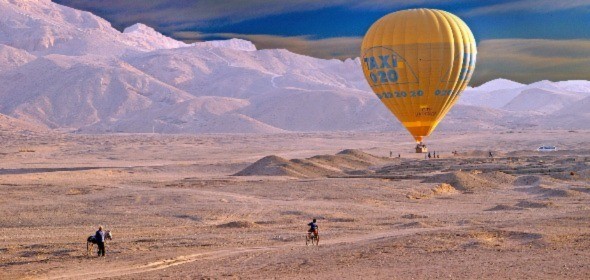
(0, 130), (590, 279)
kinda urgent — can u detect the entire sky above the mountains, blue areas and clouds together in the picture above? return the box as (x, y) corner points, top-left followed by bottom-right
(54, 0), (590, 84)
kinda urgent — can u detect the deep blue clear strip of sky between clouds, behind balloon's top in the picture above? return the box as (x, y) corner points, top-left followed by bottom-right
(196, 4), (590, 40)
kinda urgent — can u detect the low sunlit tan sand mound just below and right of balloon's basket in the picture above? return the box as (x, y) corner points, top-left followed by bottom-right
(424, 171), (512, 191)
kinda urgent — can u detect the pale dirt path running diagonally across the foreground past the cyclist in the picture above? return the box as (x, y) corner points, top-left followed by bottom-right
(47, 226), (467, 280)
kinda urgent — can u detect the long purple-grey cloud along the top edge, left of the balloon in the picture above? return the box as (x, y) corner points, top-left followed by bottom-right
(53, 0), (454, 31)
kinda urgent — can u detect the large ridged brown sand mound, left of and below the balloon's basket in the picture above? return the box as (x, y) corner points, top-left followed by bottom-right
(235, 150), (387, 178)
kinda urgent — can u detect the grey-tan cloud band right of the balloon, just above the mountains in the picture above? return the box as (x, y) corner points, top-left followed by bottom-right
(472, 39), (590, 85)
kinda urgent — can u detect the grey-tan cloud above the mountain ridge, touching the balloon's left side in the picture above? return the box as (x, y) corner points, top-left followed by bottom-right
(173, 32), (362, 59)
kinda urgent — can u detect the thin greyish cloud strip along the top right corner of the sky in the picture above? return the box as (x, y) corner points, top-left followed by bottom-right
(467, 0), (590, 16)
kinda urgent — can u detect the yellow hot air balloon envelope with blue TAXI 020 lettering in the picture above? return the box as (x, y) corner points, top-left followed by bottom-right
(361, 9), (477, 150)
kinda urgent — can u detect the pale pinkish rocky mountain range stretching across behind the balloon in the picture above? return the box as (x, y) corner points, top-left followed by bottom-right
(0, 0), (590, 133)
